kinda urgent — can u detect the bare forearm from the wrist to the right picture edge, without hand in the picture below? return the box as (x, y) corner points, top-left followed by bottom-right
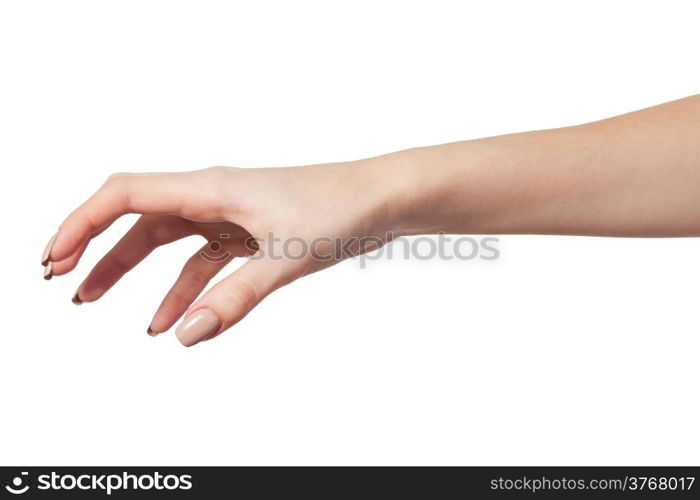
(369, 96), (700, 236)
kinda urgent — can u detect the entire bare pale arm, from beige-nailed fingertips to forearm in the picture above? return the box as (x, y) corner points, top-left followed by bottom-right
(42, 95), (700, 346)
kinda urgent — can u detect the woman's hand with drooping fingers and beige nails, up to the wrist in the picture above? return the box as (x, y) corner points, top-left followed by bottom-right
(42, 162), (396, 346)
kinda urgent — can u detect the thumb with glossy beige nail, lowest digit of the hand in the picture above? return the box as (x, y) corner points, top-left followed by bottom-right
(175, 259), (299, 347)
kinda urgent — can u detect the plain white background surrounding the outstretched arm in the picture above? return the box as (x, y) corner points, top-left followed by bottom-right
(0, 0), (700, 465)
